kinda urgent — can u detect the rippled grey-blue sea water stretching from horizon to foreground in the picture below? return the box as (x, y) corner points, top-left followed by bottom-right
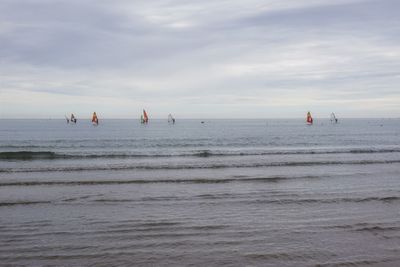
(0, 119), (400, 266)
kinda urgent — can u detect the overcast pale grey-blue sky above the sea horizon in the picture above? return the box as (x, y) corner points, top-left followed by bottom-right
(0, 0), (400, 118)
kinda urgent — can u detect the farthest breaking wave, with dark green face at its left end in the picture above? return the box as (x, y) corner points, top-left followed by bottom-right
(0, 148), (400, 160)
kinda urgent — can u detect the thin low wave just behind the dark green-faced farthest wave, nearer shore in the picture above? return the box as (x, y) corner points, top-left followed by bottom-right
(0, 159), (400, 173)
